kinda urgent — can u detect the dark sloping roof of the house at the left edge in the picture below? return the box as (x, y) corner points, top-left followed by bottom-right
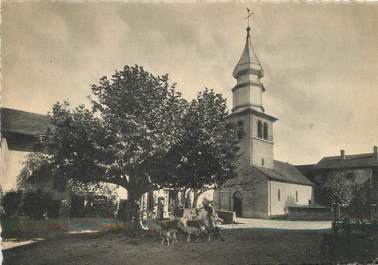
(0, 108), (50, 135)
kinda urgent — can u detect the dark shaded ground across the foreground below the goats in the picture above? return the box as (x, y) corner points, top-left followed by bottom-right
(3, 229), (378, 265)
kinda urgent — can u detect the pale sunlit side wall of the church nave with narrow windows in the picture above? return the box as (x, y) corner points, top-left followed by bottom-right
(268, 180), (312, 216)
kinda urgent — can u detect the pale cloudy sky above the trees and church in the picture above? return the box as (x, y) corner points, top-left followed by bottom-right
(1, 1), (378, 164)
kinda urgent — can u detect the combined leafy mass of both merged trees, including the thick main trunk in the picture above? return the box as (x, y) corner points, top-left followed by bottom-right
(33, 66), (237, 219)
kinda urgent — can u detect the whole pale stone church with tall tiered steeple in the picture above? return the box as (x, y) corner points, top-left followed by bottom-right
(214, 26), (313, 218)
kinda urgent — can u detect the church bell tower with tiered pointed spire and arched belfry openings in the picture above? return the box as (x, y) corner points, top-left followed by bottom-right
(230, 20), (277, 168)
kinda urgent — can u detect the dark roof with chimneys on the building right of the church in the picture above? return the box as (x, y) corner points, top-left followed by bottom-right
(314, 153), (378, 169)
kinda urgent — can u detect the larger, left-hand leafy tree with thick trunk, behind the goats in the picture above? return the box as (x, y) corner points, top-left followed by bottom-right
(44, 66), (186, 221)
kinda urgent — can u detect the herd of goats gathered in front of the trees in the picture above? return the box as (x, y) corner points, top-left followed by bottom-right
(141, 208), (224, 246)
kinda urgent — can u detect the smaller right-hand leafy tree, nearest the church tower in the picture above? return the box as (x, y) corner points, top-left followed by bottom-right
(153, 89), (239, 207)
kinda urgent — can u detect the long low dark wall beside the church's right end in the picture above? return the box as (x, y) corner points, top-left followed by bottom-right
(288, 205), (332, 221)
